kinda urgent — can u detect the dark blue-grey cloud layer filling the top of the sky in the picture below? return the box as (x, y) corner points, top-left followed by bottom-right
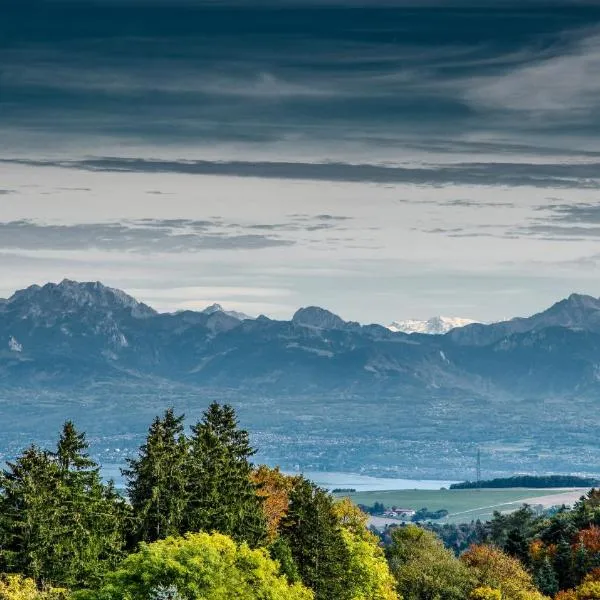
(0, 0), (600, 155)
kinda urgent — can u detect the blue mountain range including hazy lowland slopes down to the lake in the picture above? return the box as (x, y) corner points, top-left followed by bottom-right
(0, 280), (600, 478)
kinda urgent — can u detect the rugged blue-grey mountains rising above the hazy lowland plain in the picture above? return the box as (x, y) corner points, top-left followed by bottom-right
(0, 281), (600, 397)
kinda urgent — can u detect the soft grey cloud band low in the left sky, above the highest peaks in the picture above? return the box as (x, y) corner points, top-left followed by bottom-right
(0, 219), (294, 253)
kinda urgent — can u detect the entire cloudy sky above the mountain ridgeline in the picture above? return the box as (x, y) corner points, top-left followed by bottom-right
(0, 0), (600, 324)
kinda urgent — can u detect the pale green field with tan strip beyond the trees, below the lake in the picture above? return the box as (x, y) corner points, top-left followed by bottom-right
(332, 488), (583, 523)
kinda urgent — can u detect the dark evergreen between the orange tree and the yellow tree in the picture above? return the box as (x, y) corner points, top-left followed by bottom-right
(281, 478), (350, 600)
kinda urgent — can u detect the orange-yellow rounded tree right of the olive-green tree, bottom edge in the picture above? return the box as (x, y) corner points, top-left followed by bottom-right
(461, 545), (543, 600)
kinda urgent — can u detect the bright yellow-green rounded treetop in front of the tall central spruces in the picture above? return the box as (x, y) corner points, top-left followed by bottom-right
(77, 533), (313, 600)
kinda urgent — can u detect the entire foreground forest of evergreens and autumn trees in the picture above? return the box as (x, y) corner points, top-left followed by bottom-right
(0, 403), (600, 600)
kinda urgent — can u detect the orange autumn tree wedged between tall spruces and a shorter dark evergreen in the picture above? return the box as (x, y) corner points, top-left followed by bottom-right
(251, 465), (298, 542)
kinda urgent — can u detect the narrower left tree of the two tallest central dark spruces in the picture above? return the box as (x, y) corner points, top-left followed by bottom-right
(122, 408), (188, 544)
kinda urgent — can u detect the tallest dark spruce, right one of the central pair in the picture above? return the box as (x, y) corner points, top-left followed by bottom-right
(185, 403), (266, 546)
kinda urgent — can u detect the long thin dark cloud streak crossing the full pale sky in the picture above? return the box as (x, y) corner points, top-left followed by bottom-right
(0, 157), (600, 189)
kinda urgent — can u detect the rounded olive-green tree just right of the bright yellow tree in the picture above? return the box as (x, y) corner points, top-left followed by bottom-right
(387, 525), (475, 600)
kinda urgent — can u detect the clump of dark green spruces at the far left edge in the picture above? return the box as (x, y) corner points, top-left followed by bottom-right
(0, 423), (127, 586)
